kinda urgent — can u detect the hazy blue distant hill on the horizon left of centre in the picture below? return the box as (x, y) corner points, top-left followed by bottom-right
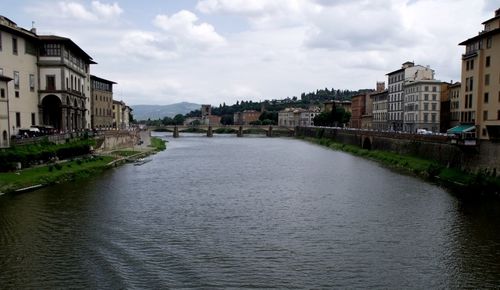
(131, 102), (201, 120)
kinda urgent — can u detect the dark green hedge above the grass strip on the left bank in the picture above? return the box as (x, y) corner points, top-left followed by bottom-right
(0, 139), (95, 171)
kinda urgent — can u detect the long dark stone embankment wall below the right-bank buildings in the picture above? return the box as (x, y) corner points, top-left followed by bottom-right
(296, 127), (500, 173)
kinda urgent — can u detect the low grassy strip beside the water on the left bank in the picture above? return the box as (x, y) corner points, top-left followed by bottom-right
(0, 156), (113, 193)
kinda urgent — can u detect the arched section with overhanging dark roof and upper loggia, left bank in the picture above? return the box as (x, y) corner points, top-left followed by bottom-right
(38, 35), (96, 132)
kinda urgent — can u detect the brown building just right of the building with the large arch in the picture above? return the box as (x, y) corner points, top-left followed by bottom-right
(90, 75), (116, 129)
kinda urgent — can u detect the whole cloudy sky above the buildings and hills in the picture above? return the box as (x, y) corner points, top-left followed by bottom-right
(0, 0), (500, 105)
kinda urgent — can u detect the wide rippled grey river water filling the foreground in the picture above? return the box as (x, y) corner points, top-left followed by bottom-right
(0, 134), (500, 289)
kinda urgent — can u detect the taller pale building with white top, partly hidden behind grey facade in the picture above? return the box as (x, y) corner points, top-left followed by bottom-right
(387, 61), (434, 131)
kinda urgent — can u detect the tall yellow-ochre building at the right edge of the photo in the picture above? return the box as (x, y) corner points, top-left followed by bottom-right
(459, 9), (500, 140)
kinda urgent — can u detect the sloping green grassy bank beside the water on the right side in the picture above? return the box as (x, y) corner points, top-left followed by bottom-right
(304, 138), (500, 195)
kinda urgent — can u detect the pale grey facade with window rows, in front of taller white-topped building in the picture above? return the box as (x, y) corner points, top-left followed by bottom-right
(403, 80), (441, 133)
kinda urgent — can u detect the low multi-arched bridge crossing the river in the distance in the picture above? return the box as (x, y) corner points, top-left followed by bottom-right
(151, 125), (295, 138)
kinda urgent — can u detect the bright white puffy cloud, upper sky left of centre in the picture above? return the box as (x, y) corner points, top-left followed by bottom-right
(153, 10), (225, 48)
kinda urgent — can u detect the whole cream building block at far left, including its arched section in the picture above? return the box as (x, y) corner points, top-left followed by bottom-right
(0, 16), (95, 144)
